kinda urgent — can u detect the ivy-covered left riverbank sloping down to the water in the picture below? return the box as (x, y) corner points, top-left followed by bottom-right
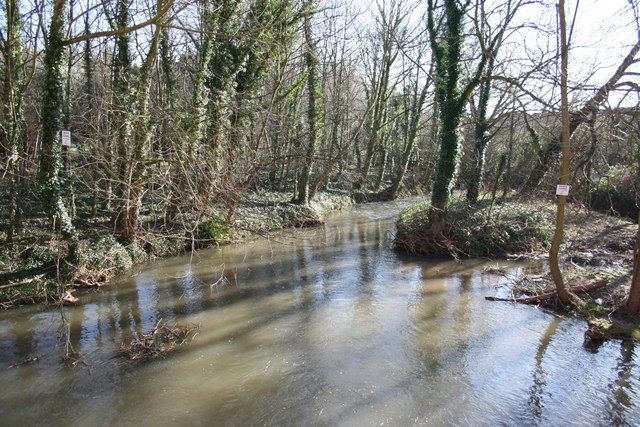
(0, 192), (353, 309)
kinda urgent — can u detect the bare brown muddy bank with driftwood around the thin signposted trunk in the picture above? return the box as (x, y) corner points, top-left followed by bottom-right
(482, 204), (640, 348)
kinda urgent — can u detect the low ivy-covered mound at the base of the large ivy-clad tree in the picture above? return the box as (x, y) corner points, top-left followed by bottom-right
(395, 200), (553, 257)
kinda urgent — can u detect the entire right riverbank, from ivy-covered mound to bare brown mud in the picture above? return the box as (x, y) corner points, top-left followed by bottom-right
(395, 200), (640, 345)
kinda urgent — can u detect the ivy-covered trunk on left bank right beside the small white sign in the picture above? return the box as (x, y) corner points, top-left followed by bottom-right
(39, 0), (76, 239)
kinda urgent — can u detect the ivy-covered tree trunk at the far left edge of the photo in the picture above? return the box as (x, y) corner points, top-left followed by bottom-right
(1, 0), (25, 243)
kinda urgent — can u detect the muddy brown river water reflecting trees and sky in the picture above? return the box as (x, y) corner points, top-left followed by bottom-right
(0, 202), (640, 426)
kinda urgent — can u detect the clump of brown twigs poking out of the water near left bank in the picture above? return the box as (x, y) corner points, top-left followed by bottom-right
(118, 319), (200, 360)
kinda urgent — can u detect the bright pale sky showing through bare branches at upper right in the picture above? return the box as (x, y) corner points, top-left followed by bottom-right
(351, 0), (640, 106)
